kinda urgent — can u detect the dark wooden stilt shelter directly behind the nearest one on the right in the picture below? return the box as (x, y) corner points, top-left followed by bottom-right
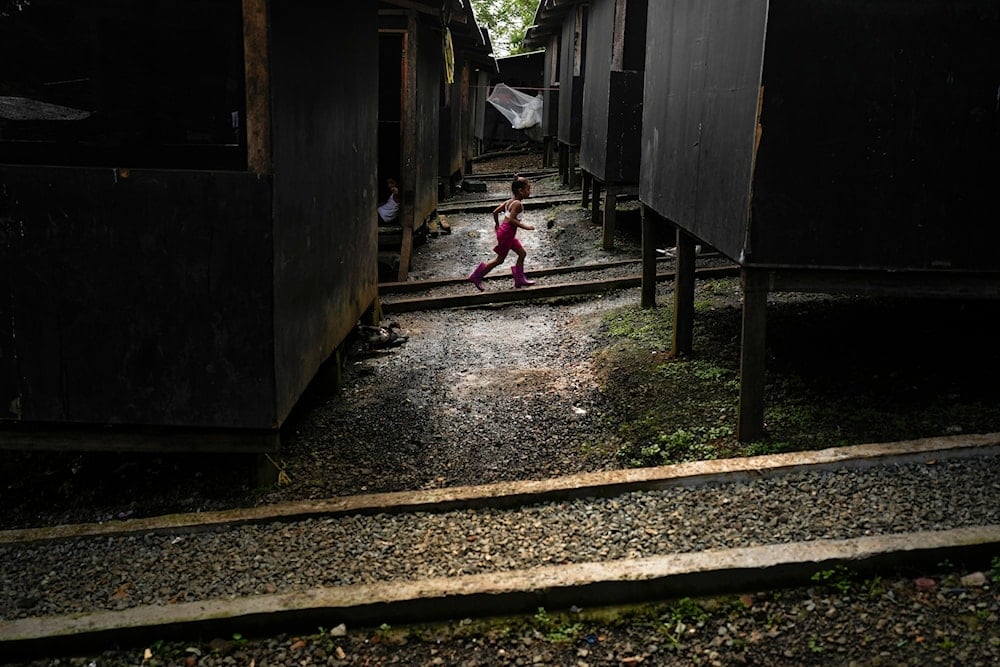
(580, 0), (646, 249)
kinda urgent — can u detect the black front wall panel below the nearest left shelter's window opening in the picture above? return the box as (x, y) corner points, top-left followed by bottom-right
(0, 167), (276, 428)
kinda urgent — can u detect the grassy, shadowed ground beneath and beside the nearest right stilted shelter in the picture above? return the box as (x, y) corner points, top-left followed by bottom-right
(595, 292), (1000, 466)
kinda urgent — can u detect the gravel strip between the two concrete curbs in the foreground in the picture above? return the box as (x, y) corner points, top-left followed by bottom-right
(0, 457), (1000, 619)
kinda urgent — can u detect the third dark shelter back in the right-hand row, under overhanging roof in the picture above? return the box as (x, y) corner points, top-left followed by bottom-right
(523, 0), (588, 186)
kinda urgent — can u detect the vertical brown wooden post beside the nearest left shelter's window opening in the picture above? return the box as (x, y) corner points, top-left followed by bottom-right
(243, 0), (271, 174)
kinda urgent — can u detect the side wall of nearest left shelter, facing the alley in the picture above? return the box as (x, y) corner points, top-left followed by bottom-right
(271, 0), (378, 418)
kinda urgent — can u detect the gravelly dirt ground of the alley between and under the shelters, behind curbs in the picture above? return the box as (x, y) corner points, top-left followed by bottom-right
(0, 149), (1000, 528)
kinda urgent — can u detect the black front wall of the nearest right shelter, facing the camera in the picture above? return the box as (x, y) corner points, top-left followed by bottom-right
(750, 0), (1000, 271)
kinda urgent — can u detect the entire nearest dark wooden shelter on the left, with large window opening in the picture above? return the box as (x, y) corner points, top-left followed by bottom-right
(0, 0), (378, 452)
